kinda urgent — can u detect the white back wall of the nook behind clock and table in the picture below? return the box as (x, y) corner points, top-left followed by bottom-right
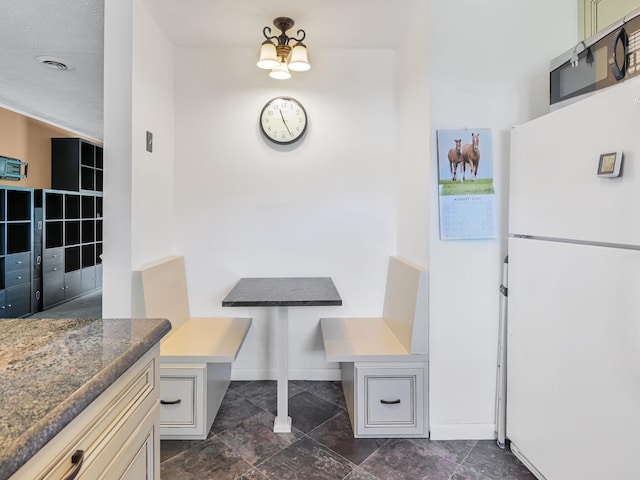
(175, 47), (397, 379)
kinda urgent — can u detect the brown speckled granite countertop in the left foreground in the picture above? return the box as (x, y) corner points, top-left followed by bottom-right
(0, 318), (171, 479)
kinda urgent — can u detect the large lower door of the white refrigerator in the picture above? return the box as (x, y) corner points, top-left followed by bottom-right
(507, 238), (640, 480)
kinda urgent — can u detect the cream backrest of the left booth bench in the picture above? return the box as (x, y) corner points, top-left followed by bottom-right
(134, 256), (189, 331)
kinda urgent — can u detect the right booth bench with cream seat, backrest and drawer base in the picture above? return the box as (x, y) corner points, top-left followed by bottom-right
(320, 257), (429, 438)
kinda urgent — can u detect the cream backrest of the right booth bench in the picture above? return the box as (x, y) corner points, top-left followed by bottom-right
(382, 257), (429, 354)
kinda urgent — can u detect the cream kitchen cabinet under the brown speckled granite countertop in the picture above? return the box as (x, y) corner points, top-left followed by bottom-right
(10, 345), (160, 480)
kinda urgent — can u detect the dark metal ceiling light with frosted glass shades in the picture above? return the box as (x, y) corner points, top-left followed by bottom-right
(257, 17), (311, 80)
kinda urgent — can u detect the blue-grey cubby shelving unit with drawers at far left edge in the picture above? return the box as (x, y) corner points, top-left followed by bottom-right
(0, 187), (34, 318)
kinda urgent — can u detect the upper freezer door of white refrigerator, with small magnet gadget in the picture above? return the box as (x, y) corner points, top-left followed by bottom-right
(509, 76), (640, 245)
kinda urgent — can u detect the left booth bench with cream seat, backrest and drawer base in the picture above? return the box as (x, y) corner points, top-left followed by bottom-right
(134, 256), (251, 440)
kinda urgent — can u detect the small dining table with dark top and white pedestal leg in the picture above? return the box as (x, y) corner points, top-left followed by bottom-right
(222, 277), (342, 433)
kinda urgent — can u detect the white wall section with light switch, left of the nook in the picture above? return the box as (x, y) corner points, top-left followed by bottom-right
(102, 0), (175, 318)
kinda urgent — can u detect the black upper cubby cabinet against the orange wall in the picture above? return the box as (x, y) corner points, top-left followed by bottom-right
(51, 138), (102, 192)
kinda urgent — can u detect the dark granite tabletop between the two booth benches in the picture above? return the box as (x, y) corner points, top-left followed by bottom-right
(222, 277), (342, 307)
